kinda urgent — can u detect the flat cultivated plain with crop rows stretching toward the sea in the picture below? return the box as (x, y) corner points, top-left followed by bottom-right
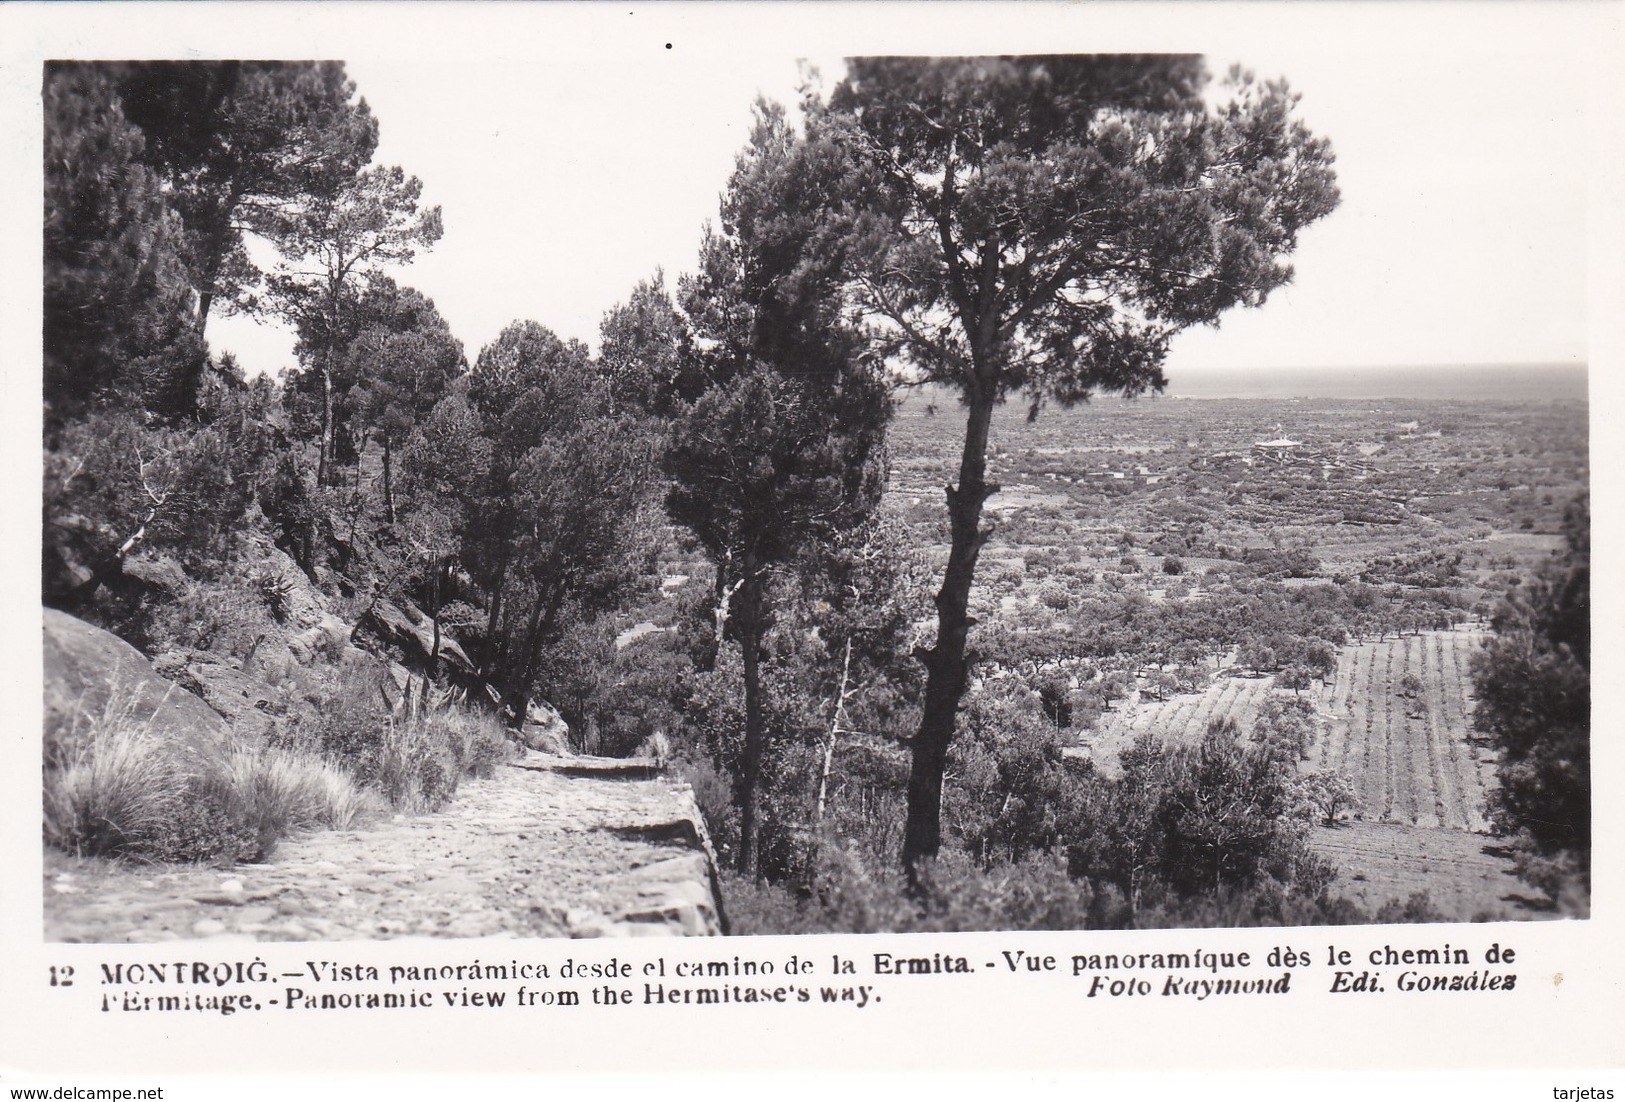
(889, 383), (1588, 918)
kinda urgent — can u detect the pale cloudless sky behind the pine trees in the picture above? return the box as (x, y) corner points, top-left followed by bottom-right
(196, 21), (1588, 388)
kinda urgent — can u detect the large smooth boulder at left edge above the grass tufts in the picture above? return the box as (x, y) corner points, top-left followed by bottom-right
(44, 608), (234, 761)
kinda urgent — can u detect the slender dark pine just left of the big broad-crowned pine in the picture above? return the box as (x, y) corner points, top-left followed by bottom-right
(666, 104), (889, 873)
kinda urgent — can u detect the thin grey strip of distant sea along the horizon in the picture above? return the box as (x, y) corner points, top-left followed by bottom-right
(1164, 364), (1588, 401)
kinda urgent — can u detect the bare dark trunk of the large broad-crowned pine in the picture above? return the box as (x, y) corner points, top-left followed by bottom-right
(904, 380), (998, 886)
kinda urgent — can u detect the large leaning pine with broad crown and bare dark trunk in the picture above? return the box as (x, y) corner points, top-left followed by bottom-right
(809, 55), (1337, 878)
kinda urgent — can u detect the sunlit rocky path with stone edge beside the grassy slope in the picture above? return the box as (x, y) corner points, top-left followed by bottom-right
(44, 753), (725, 943)
